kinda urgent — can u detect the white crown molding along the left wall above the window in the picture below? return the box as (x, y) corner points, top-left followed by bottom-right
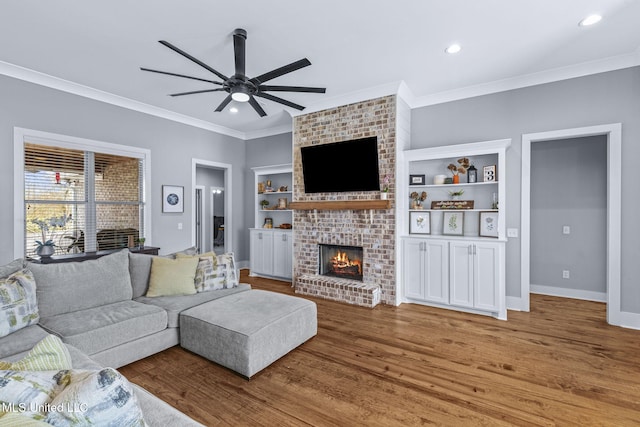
(0, 61), (245, 139)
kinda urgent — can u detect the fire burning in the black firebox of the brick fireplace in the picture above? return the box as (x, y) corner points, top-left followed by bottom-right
(318, 244), (362, 281)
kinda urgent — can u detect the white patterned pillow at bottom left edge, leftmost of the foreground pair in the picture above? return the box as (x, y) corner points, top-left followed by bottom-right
(0, 370), (70, 419)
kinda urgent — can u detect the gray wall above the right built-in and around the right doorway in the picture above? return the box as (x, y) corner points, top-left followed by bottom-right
(411, 67), (640, 313)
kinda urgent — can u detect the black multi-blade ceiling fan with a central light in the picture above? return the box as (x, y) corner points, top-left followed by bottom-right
(140, 28), (326, 117)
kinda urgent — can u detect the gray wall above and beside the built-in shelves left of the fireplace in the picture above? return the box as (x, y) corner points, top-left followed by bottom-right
(243, 132), (293, 249)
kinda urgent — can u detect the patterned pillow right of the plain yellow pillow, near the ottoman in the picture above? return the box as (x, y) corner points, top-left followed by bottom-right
(176, 252), (238, 292)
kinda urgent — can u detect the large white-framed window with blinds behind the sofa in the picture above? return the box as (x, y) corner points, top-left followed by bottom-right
(16, 129), (148, 256)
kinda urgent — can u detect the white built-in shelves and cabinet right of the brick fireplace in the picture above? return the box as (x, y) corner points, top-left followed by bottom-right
(397, 139), (511, 319)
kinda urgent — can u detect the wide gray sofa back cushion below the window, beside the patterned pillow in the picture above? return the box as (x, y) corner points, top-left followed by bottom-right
(27, 249), (132, 317)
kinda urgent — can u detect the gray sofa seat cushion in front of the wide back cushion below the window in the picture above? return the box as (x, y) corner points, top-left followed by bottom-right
(40, 301), (167, 355)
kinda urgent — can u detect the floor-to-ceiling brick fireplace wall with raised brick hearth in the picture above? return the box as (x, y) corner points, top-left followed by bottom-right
(293, 95), (396, 307)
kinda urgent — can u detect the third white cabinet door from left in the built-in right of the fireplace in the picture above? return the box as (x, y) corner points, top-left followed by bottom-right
(449, 242), (474, 307)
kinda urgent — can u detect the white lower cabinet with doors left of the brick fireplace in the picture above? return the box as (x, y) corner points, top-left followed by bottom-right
(249, 228), (293, 280)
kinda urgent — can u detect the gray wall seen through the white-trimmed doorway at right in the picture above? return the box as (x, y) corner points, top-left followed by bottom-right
(530, 135), (607, 294)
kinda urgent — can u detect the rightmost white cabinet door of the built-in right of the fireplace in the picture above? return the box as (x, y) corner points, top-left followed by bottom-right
(473, 242), (500, 311)
